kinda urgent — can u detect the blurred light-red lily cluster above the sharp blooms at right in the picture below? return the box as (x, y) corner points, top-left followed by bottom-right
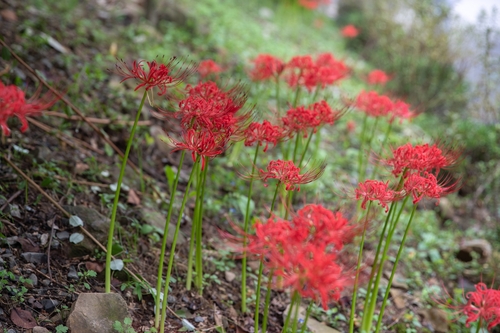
(354, 91), (416, 122)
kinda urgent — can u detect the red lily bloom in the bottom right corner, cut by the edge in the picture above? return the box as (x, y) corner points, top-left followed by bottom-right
(463, 282), (500, 330)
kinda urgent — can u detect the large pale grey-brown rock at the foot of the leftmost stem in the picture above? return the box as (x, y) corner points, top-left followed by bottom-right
(66, 293), (129, 333)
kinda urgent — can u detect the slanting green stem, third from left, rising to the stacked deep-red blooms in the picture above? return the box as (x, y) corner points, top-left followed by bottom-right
(157, 156), (200, 333)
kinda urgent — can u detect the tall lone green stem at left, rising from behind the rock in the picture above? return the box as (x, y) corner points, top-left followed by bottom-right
(104, 91), (147, 293)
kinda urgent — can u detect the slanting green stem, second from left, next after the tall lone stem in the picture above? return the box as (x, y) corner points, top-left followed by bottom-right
(155, 150), (186, 327)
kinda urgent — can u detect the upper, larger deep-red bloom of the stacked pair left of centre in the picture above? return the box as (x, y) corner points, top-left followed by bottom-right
(176, 81), (251, 134)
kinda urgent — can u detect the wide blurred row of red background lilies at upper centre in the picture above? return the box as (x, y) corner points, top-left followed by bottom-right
(249, 53), (350, 91)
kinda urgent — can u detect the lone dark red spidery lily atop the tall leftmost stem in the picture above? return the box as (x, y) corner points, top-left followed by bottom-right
(116, 57), (196, 96)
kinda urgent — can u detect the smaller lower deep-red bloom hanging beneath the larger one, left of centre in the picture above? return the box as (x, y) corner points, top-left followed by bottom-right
(172, 128), (229, 170)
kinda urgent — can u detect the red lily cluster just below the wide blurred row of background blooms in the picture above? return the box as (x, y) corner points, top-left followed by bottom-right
(281, 101), (343, 138)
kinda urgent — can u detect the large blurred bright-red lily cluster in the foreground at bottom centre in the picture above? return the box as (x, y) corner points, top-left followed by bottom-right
(246, 205), (353, 309)
